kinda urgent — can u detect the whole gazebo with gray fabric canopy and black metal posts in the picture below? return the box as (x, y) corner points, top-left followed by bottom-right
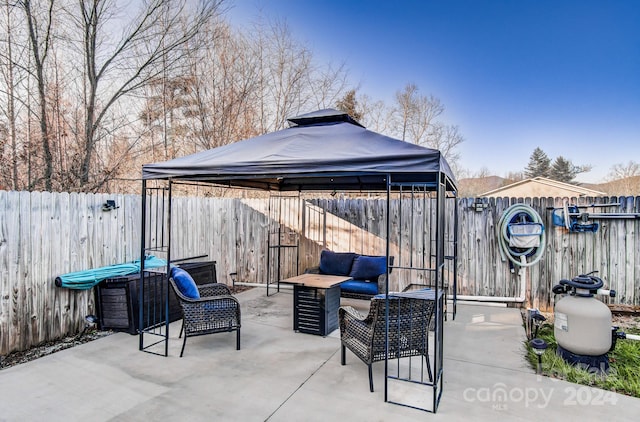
(139, 109), (457, 412)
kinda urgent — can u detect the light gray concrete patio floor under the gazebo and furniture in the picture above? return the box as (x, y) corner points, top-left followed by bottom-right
(0, 288), (640, 422)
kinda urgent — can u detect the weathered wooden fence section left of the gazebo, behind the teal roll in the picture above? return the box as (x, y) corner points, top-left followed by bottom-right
(0, 191), (141, 355)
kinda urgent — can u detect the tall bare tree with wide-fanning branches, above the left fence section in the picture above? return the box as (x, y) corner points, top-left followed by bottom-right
(72, 0), (223, 189)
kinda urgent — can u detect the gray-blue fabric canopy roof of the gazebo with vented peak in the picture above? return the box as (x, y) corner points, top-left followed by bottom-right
(142, 109), (456, 191)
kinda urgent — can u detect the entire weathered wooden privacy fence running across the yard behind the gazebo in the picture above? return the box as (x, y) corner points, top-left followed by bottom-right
(0, 191), (640, 355)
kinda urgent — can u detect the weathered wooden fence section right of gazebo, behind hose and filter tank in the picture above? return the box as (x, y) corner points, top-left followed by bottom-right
(458, 197), (640, 311)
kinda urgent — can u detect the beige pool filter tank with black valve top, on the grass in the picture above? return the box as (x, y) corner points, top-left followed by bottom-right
(553, 273), (617, 373)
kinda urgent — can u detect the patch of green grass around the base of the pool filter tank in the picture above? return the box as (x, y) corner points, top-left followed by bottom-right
(525, 323), (640, 398)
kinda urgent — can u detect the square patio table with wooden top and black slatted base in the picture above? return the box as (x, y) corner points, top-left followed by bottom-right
(281, 274), (351, 336)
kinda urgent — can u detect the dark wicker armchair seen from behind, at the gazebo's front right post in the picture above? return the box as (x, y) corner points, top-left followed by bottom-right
(338, 297), (435, 392)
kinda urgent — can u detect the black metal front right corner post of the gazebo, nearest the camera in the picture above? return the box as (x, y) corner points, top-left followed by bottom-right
(384, 172), (448, 413)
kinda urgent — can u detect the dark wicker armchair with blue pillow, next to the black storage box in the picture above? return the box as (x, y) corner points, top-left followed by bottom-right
(169, 277), (240, 357)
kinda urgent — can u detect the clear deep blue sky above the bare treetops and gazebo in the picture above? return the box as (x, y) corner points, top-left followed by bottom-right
(229, 0), (640, 182)
